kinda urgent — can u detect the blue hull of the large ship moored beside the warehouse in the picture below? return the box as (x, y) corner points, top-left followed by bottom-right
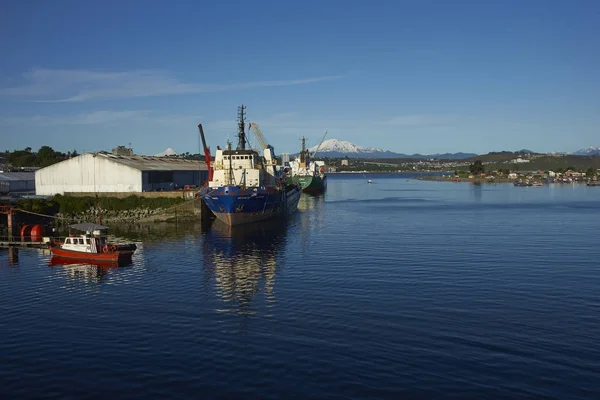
(203, 185), (301, 226)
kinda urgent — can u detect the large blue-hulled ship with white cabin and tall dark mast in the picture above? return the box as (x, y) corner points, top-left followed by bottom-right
(200, 105), (301, 225)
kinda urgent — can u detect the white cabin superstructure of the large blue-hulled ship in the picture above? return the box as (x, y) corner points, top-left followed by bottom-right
(208, 148), (277, 188)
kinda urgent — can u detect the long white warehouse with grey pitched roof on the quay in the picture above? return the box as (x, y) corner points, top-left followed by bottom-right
(35, 153), (208, 196)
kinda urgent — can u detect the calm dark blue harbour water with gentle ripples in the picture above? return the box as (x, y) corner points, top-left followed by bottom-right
(0, 175), (600, 399)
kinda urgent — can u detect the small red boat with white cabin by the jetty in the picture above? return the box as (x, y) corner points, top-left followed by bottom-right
(48, 223), (137, 263)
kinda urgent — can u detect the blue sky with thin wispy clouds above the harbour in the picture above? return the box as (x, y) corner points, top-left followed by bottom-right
(0, 0), (600, 154)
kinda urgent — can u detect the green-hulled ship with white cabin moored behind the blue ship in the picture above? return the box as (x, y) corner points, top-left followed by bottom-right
(288, 136), (327, 193)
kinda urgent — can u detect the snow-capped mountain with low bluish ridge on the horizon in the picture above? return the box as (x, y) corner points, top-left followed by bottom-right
(308, 139), (477, 159)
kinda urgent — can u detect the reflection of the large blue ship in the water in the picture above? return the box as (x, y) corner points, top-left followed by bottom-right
(203, 220), (287, 315)
